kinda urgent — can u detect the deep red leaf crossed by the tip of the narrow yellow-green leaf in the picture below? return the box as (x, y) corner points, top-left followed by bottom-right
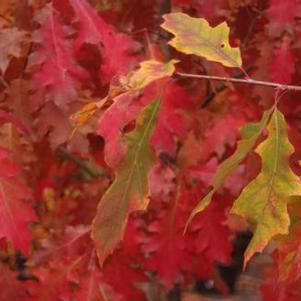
(179, 184), (232, 279)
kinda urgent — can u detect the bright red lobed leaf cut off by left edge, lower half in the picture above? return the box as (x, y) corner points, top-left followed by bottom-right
(0, 149), (36, 254)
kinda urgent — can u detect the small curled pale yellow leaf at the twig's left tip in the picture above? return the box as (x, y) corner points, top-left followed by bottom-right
(128, 60), (179, 90)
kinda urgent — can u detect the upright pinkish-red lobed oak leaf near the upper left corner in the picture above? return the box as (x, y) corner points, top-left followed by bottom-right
(30, 4), (87, 111)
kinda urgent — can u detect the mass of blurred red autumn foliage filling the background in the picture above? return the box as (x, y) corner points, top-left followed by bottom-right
(0, 0), (301, 301)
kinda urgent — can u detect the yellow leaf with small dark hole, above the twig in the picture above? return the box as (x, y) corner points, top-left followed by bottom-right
(161, 13), (242, 67)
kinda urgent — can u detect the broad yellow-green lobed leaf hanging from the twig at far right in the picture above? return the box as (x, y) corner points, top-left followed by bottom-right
(231, 109), (301, 265)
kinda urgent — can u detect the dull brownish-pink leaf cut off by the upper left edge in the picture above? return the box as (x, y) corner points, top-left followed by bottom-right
(0, 27), (27, 74)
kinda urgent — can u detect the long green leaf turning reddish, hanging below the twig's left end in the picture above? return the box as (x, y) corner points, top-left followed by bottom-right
(92, 100), (160, 264)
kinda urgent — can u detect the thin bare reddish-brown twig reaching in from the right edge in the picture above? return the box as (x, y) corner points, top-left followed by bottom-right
(176, 72), (301, 91)
